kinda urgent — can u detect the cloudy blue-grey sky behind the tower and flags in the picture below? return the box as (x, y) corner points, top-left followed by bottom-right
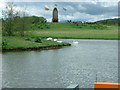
(0, 0), (118, 22)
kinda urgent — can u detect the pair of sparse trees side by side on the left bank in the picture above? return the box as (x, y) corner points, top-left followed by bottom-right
(2, 2), (26, 36)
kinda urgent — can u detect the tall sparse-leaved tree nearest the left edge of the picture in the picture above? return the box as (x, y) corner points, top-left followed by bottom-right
(2, 2), (18, 36)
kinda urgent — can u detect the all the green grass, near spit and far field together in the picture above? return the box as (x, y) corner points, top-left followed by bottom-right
(1, 23), (118, 50)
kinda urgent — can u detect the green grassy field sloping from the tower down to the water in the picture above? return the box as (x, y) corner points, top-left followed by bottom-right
(26, 23), (118, 40)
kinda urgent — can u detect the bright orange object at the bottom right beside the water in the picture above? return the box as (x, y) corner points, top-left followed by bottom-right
(94, 82), (120, 90)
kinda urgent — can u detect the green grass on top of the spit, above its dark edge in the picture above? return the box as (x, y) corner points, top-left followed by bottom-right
(2, 36), (69, 50)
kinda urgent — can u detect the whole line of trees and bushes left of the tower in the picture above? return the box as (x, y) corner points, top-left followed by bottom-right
(2, 2), (46, 36)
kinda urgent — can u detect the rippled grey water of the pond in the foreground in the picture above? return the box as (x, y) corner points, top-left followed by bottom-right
(2, 39), (118, 88)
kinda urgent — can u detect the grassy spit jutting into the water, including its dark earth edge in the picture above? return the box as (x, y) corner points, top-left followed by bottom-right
(2, 36), (70, 51)
